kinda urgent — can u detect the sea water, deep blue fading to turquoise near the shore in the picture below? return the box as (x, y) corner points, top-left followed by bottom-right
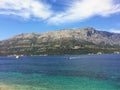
(0, 54), (120, 90)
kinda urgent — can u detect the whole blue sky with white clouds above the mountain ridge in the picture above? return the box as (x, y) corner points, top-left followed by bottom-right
(0, 0), (120, 40)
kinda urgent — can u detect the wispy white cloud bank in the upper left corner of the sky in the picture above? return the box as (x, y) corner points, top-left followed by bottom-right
(0, 0), (52, 19)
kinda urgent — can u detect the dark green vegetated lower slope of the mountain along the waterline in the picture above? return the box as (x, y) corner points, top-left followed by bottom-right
(0, 40), (120, 55)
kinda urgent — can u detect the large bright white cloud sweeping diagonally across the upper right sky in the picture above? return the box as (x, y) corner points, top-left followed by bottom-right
(49, 0), (120, 24)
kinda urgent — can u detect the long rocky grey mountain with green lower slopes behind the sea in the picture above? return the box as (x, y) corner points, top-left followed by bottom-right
(0, 27), (120, 55)
